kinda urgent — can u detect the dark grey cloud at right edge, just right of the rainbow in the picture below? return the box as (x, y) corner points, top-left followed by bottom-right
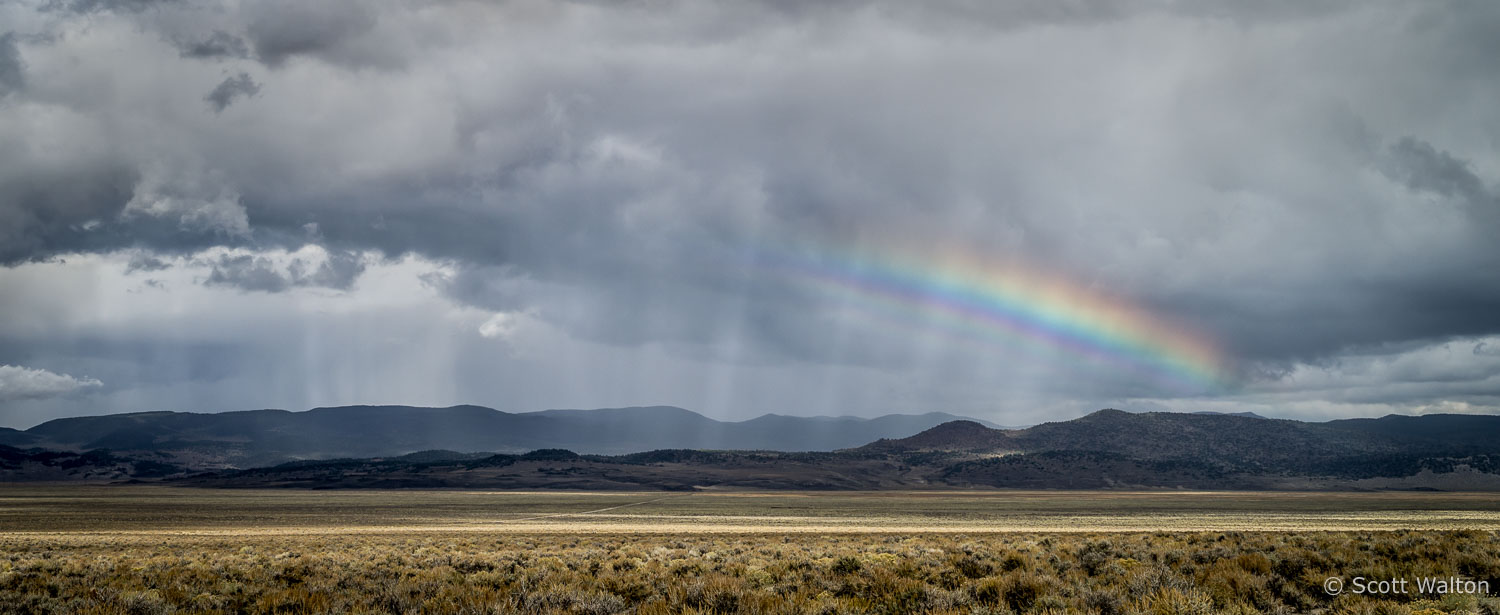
(1163, 137), (1500, 360)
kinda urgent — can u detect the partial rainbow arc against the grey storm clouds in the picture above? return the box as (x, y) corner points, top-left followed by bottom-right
(756, 246), (1227, 390)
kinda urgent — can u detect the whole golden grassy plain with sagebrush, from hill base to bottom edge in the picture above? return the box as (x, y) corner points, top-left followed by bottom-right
(0, 486), (1500, 615)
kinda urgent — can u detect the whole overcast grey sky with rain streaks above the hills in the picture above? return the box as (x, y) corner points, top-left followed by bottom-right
(0, 0), (1500, 428)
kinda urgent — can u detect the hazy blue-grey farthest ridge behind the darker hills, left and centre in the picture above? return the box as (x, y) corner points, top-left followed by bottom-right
(0, 405), (996, 468)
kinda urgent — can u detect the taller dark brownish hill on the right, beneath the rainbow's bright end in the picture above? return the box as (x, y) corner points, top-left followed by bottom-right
(857, 410), (1500, 488)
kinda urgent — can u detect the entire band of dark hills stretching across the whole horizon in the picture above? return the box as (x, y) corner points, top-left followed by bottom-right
(11, 407), (1500, 491)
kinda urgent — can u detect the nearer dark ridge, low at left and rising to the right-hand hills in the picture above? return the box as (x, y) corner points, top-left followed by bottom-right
(170, 410), (1500, 491)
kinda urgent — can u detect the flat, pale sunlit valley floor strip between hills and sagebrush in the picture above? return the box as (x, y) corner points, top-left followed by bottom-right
(0, 485), (1500, 536)
